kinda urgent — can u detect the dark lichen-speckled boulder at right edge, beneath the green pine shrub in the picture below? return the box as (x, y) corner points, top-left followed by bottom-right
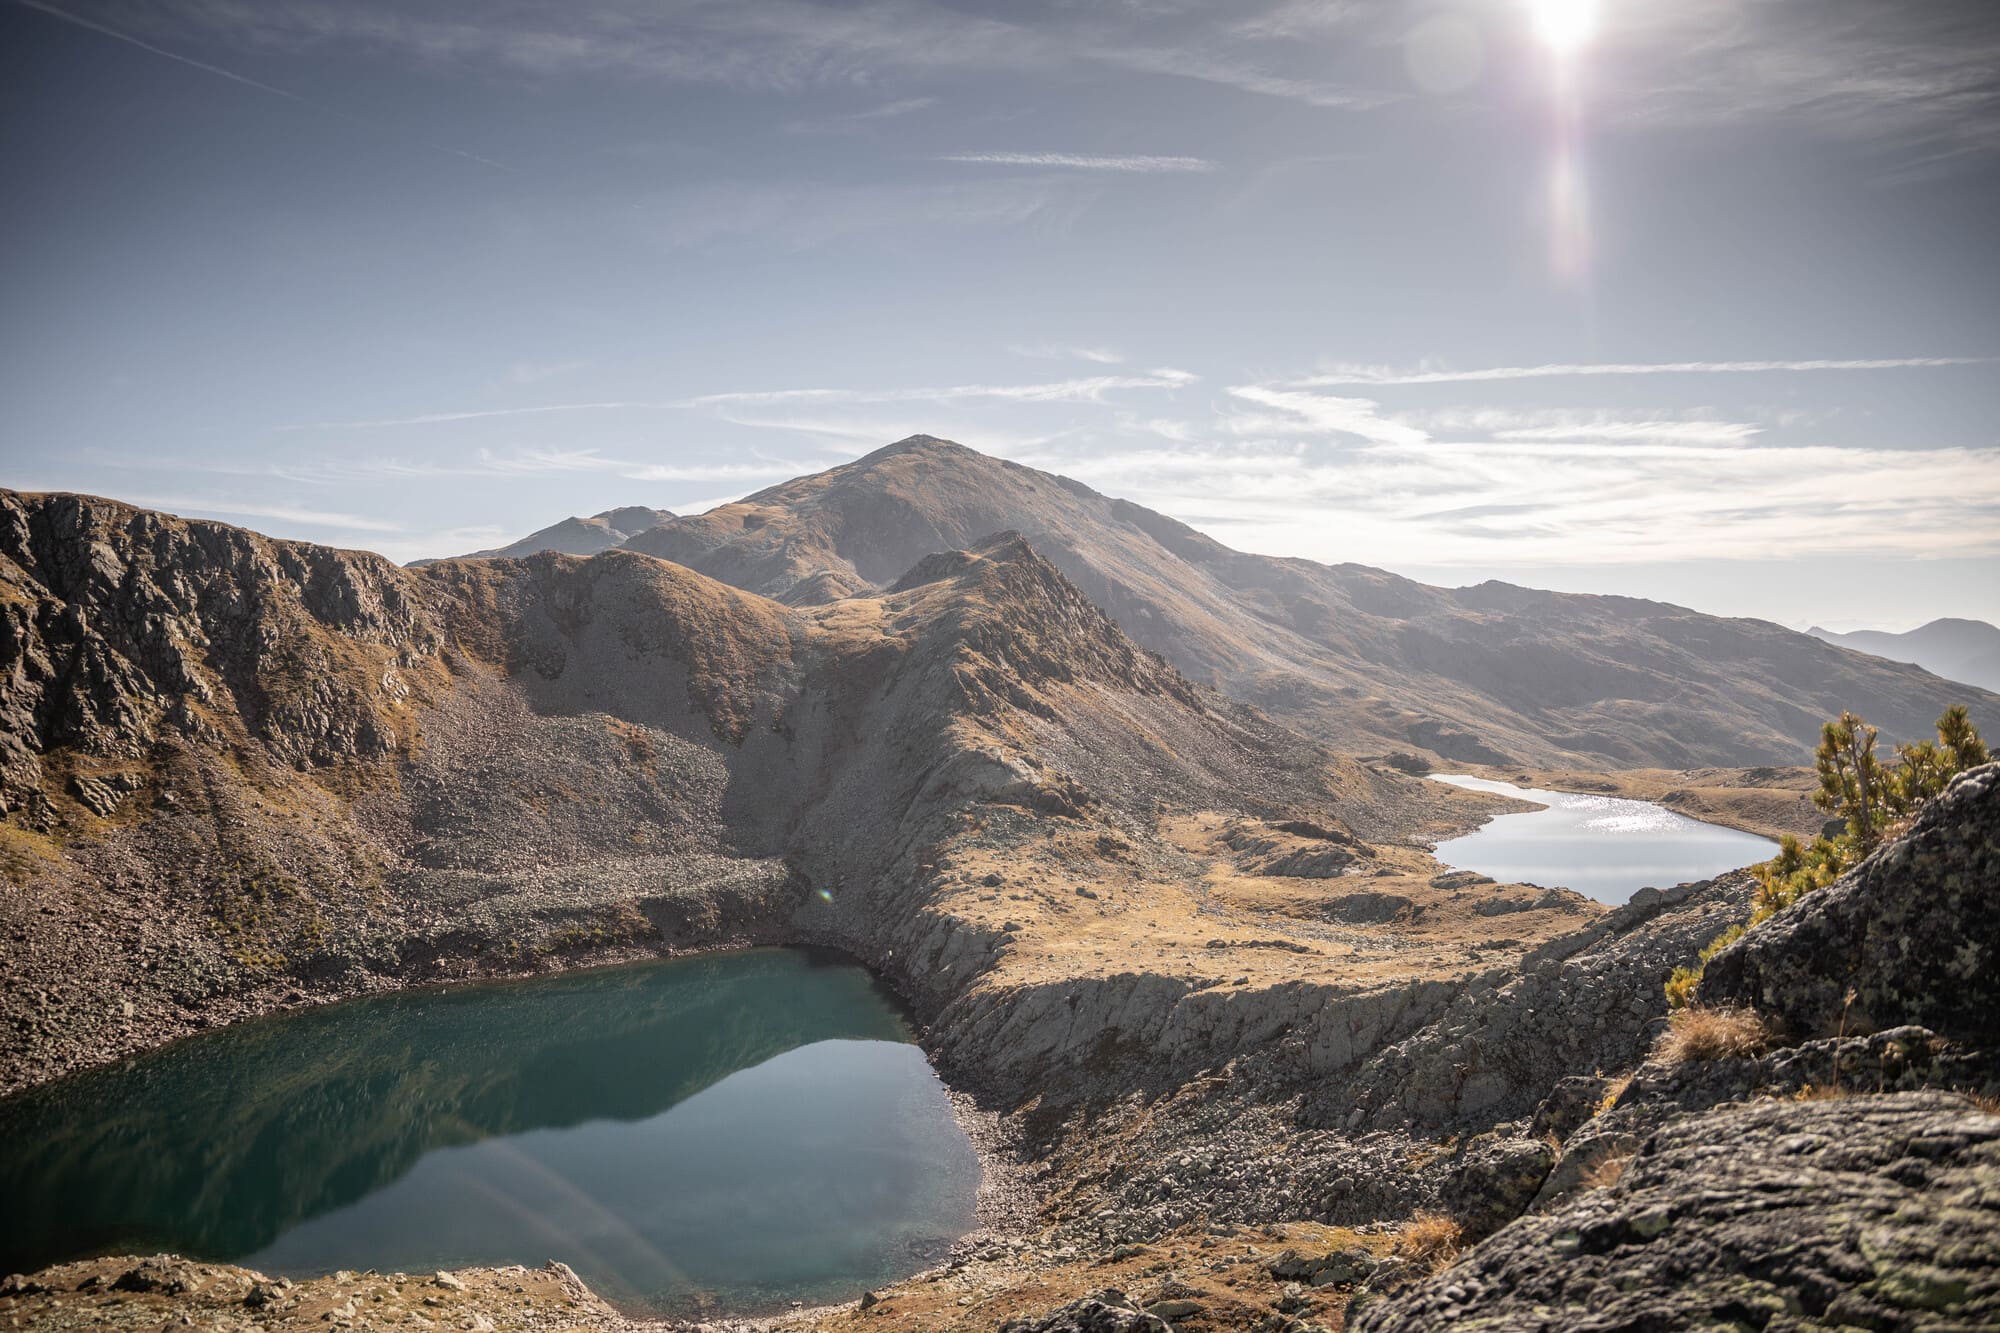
(1700, 765), (2000, 1047)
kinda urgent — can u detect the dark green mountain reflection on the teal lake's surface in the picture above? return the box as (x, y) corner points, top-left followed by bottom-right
(0, 951), (908, 1271)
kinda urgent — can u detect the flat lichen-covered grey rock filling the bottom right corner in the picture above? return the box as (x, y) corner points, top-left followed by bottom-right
(1350, 1093), (2000, 1333)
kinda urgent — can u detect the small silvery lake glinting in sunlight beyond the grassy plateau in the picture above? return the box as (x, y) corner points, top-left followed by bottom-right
(1436, 775), (1778, 905)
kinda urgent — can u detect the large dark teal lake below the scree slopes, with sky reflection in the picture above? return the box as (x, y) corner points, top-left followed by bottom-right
(0, 949), (980, 1315)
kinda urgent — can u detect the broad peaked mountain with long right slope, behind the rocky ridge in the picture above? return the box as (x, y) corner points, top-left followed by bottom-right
(426, 436), (2000, 769)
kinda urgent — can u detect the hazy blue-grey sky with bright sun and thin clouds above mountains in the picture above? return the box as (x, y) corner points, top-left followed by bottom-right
(0, 0), (2000, 628)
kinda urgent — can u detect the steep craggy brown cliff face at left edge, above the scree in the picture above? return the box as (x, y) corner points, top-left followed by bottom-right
(0, 490), (438, 808)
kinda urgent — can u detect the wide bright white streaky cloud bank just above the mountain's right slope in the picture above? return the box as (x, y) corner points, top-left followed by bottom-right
(1168, 374), (2000, 568)
